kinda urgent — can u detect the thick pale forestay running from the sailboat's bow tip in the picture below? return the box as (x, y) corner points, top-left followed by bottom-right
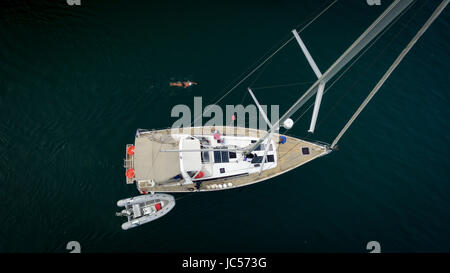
(331, 0), (450, 148)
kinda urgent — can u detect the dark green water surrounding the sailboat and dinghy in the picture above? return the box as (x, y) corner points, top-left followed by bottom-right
(0, 0), (450, 252)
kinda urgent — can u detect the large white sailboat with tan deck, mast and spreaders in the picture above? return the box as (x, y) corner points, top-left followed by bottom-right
(124, 0), (448, 193)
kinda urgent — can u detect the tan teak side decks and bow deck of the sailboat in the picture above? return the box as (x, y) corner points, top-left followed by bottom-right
(130, 126), (330, 192)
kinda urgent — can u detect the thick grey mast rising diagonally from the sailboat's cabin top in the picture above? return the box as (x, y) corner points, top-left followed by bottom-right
(247, 0), (413, 153)
